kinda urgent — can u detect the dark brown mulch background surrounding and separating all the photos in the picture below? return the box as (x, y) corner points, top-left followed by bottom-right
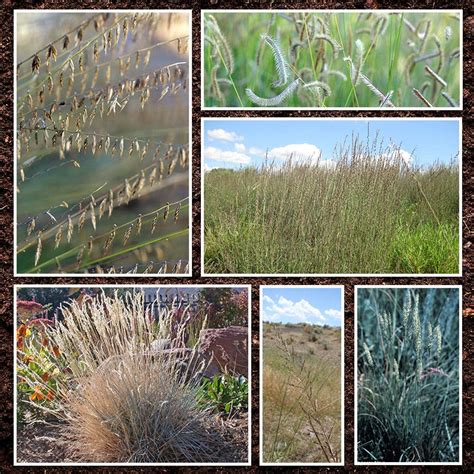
(0, 0), (474, 472)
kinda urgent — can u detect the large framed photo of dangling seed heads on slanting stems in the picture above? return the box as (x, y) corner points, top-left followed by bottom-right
(14, 10), (191, 276)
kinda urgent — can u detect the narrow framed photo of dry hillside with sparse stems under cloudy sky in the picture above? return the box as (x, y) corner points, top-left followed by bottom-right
(260, 285), (344, 466)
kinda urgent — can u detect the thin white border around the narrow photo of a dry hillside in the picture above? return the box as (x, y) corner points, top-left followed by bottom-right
(258, 285), (345, 467)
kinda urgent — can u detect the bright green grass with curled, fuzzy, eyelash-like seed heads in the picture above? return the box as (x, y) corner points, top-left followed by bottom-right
(203, 10), (461, 108)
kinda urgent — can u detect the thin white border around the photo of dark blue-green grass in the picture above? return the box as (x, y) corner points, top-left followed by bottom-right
(354, 285), (464, 466)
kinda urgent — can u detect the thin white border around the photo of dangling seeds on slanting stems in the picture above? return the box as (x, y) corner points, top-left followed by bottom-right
(13, 8), (193, 278)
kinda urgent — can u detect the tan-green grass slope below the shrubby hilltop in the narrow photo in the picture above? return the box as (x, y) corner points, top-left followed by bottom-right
(262, 325), (342, 463)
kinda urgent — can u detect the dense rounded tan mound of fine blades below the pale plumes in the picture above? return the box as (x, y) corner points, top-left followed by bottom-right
(66, 356), (226, 463)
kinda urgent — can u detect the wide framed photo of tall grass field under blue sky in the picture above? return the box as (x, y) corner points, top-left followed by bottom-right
(201, 118), (462, 276)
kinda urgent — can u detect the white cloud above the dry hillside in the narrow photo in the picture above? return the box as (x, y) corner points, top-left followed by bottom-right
(263, 296), (326, 324)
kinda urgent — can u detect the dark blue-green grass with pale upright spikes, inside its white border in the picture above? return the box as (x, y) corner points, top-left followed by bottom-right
(356, 288), (460, 463)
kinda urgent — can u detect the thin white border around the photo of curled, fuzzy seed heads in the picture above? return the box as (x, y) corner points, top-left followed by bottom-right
(201, 8), (464, 112)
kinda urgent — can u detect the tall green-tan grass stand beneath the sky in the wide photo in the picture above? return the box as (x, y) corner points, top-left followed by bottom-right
(204, 133), (459, 274)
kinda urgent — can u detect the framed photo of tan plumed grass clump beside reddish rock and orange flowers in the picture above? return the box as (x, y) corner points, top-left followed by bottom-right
(13, 285), (251, 466)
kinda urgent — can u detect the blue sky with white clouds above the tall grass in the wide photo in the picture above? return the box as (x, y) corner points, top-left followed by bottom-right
(203, 119), (460, 170)
